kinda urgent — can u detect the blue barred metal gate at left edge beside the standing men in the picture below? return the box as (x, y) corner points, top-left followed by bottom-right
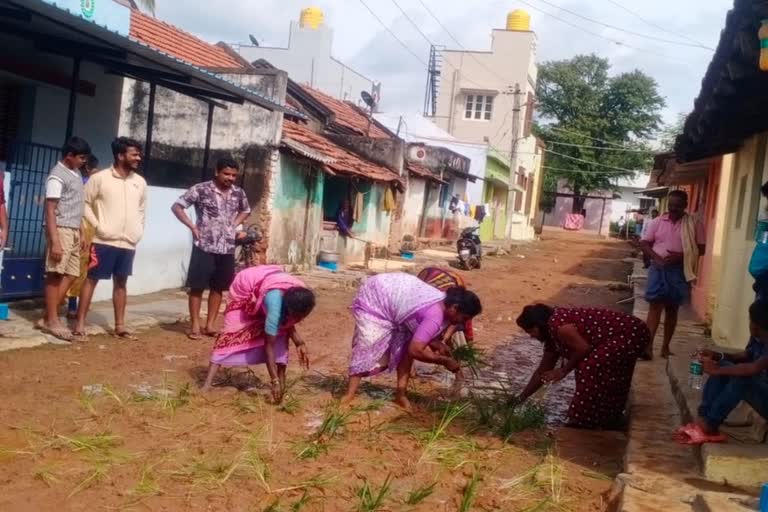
(0, 142), (61, 299)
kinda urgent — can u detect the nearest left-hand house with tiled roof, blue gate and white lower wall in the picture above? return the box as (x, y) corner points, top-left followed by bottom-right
(0, 0), (289, 299)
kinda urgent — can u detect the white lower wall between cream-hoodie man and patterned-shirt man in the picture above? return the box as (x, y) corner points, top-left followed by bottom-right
(94, 187), (195, 300)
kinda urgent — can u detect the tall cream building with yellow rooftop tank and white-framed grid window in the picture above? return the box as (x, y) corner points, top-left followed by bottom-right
(432, 10), (541, 238)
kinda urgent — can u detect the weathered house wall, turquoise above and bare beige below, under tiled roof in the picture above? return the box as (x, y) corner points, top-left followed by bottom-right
(267, 153), (325, 268)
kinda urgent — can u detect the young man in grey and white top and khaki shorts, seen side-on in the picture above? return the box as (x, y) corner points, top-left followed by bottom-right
(42, 137), (91, 341)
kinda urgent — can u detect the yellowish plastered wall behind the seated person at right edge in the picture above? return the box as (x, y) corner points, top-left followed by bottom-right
(712, 137), (768, 349)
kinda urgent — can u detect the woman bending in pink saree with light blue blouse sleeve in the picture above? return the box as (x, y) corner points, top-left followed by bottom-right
(203, 265), (315, 402)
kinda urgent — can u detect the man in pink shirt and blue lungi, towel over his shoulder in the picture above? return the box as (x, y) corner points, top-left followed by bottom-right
(640, 190), (705, 360)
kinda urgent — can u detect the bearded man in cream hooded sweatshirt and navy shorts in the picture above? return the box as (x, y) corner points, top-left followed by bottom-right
(74, 137), (147, 340)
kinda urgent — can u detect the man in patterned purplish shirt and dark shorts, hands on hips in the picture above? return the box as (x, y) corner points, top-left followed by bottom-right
(171, 158), (251, 340)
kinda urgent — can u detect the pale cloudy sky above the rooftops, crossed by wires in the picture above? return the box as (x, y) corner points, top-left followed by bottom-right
(156, 0), (733, 125)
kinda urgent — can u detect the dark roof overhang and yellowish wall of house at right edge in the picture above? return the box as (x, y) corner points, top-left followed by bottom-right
(675, 0), (768, 349)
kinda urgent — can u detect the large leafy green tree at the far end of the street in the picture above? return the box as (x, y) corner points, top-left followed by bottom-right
(536, 55), (664, 213)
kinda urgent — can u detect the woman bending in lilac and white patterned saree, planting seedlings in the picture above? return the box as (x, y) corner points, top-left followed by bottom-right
(342, 273), (482, 408)
